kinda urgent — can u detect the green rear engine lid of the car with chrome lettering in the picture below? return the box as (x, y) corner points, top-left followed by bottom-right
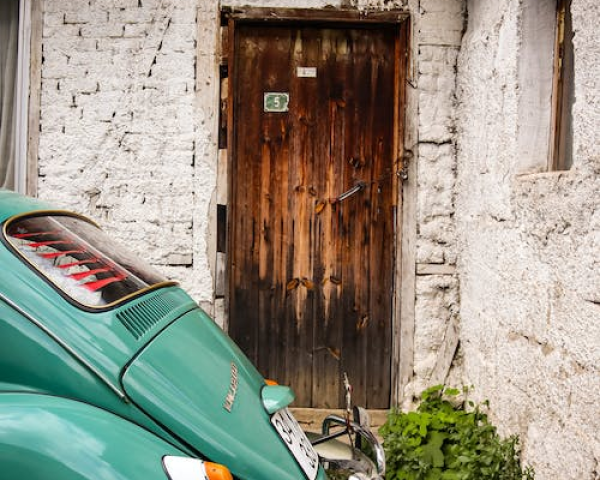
(122, 309), (324, 480)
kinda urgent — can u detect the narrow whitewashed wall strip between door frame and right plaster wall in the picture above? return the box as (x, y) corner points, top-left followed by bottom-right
(403, 0), (466, 400)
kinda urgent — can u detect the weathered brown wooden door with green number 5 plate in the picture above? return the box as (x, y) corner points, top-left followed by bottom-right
(228, 24), (401, 408)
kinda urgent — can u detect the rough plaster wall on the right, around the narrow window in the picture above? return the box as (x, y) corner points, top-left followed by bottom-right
(456, 0), (600, 480)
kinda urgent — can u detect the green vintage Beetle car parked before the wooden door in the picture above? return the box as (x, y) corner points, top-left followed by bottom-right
(0, 190), (385, 480)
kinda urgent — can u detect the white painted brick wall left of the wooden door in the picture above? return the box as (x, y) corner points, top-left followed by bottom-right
(39, 0), (216, 302)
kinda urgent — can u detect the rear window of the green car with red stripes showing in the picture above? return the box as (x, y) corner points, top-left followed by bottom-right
(5, 214), (166, 308)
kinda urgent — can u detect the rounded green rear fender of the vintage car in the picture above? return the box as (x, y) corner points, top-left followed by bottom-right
(0, 393), (186, 480)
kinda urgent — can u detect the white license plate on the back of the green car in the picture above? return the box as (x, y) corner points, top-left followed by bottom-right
(271, 408), (319, 480)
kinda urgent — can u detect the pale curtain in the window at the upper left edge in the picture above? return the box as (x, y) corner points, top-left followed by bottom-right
(0, 0), (19, 188)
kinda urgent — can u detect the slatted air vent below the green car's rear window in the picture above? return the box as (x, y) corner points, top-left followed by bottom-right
(117, 293), (180, 340)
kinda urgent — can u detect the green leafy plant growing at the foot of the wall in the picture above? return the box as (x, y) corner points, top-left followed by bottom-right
(379, 385), (534, 480)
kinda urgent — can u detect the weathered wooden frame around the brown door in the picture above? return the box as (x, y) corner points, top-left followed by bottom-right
(220, 7), (414, 405)
